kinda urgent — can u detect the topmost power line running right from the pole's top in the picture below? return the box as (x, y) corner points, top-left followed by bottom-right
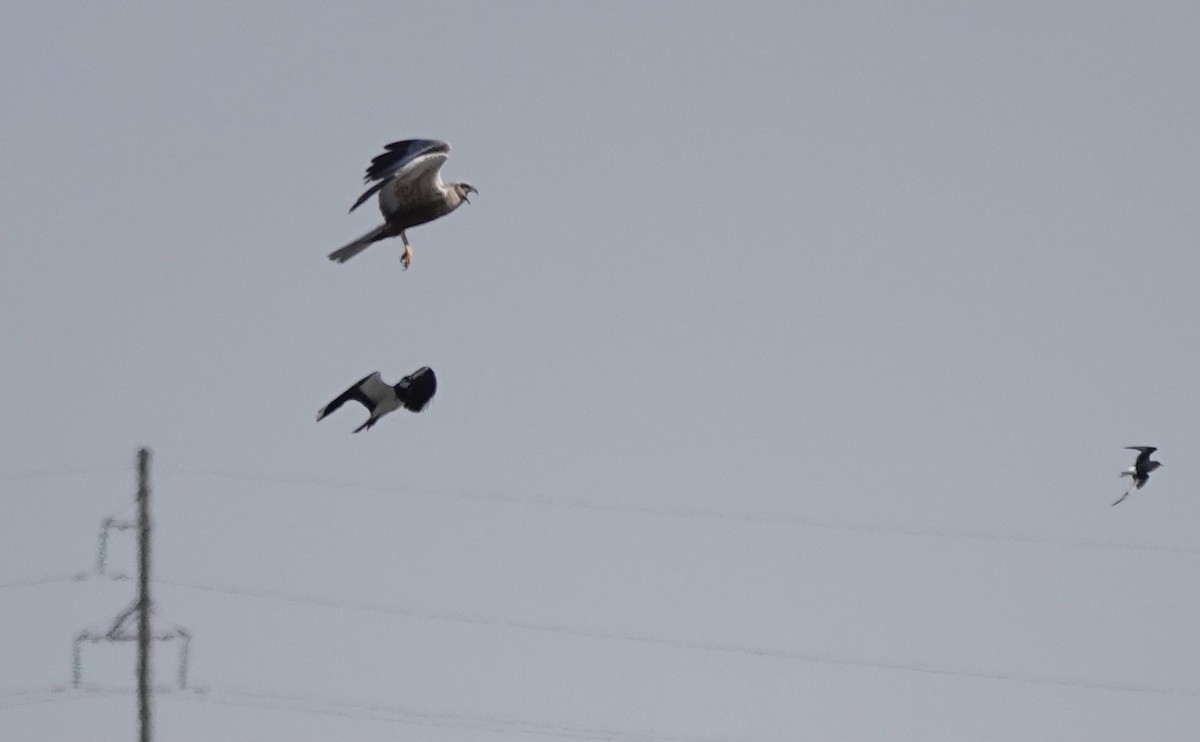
(162, 467), (1200, 557)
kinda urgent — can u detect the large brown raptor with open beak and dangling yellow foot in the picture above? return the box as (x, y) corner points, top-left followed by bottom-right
(329, 139), (479, 269)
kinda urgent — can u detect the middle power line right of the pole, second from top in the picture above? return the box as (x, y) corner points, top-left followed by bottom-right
(156, 579), (1200, 699)
